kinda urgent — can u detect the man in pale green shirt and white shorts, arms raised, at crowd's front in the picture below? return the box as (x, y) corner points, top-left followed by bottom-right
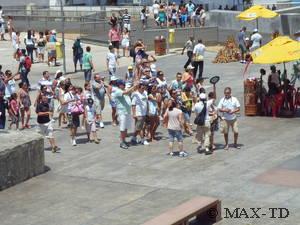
(112, 80), (136, 149)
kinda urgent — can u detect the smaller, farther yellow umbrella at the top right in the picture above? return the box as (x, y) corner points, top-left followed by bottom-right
(236, 5), (278, 20)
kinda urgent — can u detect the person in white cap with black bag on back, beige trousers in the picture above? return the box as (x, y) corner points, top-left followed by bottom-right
(195, 93), (211, 154)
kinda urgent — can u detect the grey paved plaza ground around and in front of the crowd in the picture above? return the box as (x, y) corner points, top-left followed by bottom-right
(0, 37), (300, 225)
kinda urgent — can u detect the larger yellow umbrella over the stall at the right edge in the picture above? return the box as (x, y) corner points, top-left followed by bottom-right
(251, 36), (300, 64)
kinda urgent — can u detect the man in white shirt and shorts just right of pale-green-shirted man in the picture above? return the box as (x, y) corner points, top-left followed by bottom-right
(131, 82), (149, 145)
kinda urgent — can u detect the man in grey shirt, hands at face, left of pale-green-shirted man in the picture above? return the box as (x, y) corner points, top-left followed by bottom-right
(92, 74), (105, 128)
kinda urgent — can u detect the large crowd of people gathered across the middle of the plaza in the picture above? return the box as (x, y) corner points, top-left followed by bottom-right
(0, 28), (240, 157)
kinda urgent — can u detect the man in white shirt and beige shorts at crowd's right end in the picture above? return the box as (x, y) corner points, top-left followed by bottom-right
(218, 87), (241, 150)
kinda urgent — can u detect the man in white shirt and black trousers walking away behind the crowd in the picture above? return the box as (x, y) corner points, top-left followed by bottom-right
(193, 39), (205, 79)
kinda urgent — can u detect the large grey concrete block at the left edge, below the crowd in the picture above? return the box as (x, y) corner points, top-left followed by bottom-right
(0, 131), (45, 191)
